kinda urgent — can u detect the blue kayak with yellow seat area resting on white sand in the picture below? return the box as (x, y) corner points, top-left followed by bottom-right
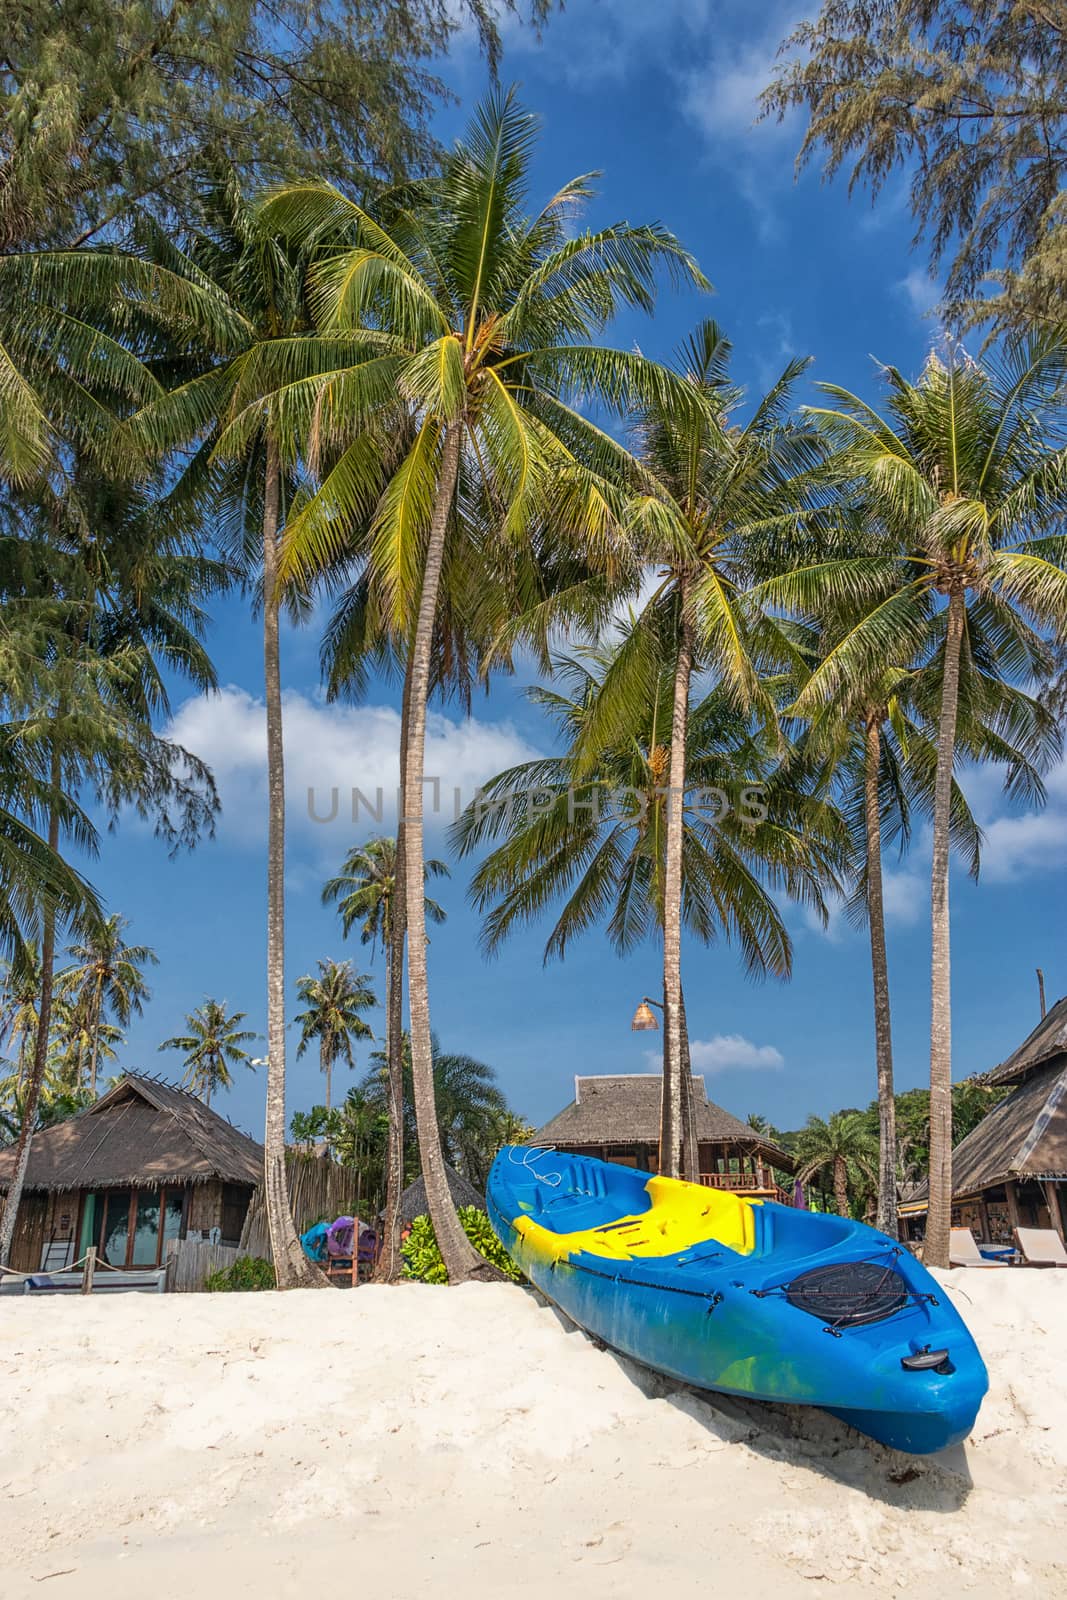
(486, 1146), (989, 1454)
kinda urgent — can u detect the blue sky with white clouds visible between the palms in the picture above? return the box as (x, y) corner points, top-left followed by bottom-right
(81, 0), (1067, 1134)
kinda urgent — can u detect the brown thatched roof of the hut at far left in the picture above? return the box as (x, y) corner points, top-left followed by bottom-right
(0, 1072), (262, 1190)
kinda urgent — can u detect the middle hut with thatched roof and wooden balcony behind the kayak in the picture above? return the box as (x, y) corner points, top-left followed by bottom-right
(528, 1072), (795, 1203)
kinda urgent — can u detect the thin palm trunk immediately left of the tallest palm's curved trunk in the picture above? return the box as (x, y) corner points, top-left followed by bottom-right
(374, 651), (413, 1283)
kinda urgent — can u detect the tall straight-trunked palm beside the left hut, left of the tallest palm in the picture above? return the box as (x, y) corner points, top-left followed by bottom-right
(128, 174), (366, 1288)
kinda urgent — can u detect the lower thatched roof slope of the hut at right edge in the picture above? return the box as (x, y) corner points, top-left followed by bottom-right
(913, 1062), (1067, 1200)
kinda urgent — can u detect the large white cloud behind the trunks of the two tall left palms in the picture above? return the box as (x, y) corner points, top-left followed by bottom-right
(166, 685), (537, 846)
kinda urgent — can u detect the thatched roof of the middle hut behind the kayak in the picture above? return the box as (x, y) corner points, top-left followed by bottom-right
(528, 1072), (793, 1173)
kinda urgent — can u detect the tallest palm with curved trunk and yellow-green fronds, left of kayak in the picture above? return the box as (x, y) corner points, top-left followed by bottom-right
(262, 94), (704, 1282)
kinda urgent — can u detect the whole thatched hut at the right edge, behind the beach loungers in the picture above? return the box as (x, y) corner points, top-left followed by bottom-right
(901, 995), (1067, 1245)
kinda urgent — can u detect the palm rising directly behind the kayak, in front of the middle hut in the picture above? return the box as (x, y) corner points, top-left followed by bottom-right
(566, 322), (822, 1178)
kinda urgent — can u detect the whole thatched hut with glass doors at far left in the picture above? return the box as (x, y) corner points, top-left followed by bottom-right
(0, 1072), (262, 1272)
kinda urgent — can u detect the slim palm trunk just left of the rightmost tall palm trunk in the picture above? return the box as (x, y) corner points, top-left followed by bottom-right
(864, 712), (897, 1238)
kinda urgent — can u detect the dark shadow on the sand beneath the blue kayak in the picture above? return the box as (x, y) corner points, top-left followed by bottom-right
(533, 1290), (974, 1512)
